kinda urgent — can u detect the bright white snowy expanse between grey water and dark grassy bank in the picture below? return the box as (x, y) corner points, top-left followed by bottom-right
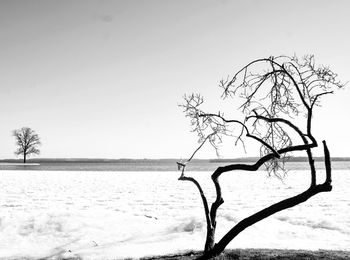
(0, 170), (350, 259)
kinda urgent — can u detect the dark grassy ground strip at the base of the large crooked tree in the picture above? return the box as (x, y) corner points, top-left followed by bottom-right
(140, 248), (350, 260)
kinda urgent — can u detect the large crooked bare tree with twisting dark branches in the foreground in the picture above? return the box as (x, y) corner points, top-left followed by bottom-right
(178, 55), (344, 259)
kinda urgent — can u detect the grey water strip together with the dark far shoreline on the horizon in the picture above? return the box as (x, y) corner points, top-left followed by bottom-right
(0, 157), (350, 172)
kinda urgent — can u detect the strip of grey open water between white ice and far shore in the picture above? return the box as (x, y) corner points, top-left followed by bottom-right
(0, 160), (350, 171)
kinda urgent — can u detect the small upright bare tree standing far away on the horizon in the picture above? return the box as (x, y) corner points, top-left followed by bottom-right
(12, 127), (41, 163)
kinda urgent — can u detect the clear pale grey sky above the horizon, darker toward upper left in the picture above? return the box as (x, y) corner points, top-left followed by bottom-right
(0, 0), (350, 158)
